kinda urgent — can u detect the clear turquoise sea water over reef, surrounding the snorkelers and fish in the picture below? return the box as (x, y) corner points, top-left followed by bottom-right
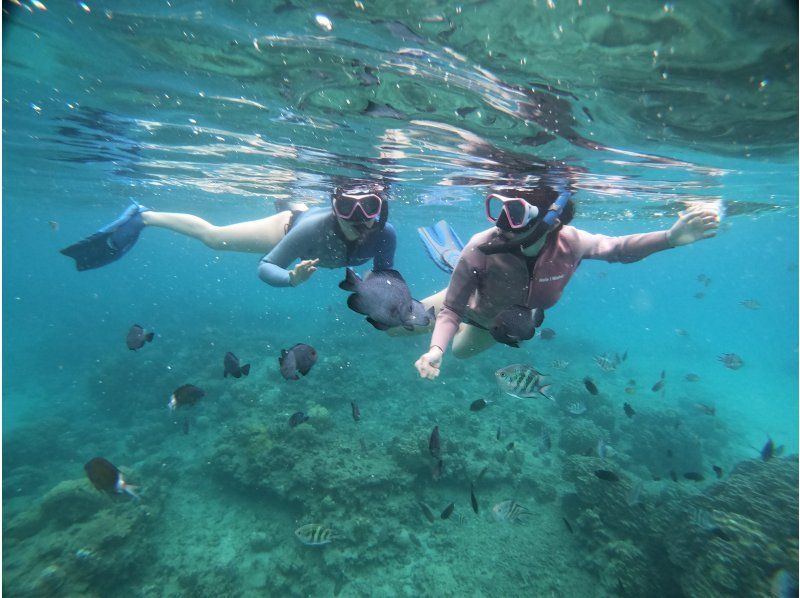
(3, 0), (798, 596)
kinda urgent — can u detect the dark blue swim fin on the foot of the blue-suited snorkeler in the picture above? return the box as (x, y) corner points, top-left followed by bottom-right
(61, 202), (147, 271)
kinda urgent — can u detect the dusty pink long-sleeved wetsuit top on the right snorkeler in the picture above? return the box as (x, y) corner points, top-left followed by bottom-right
(431, 226), (670, 351)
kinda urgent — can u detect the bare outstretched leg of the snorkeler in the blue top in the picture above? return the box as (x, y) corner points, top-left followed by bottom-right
(142, 211), (292, 254)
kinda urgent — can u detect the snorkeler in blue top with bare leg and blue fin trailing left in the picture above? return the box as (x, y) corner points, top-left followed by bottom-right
(61, 181), (397, 287)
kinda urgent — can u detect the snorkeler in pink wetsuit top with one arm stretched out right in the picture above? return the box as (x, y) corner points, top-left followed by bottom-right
(415, 186), (719, 379)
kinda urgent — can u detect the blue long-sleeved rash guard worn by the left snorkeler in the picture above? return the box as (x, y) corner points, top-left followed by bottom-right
(258, 208), (397, 287)
